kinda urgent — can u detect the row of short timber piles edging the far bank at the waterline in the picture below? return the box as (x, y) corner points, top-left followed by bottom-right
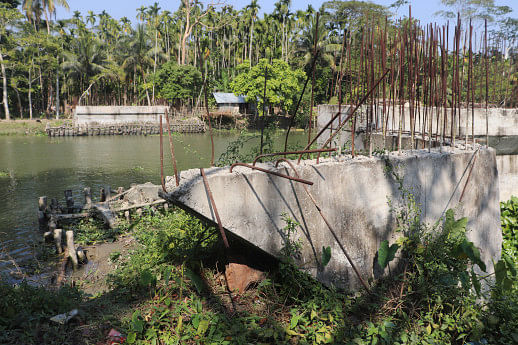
(45, 119), (206, 137)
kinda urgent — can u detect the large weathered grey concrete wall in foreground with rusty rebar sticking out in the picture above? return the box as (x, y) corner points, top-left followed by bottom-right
(167, 148), (502, 289)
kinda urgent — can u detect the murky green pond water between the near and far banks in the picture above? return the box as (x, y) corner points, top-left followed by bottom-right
(0, 132), (305, 271)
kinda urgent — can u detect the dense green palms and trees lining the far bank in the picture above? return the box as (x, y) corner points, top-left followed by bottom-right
(0, 0), (518, 118)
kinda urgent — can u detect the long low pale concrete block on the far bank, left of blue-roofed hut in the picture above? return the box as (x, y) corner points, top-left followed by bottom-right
(74, 106), (168, 125)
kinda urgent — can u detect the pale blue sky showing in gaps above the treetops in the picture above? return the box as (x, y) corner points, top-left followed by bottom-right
(56, 0), (518, 24)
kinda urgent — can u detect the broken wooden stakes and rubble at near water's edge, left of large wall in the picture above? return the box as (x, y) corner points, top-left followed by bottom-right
(38, 182), (169, 268)
